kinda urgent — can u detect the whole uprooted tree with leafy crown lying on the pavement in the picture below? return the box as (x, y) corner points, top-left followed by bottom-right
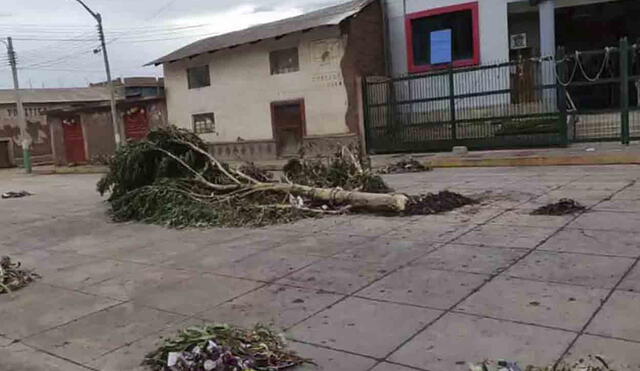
(98, 127), (471, 227)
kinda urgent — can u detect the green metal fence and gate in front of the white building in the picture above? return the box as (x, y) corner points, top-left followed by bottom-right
(363, 40), (640, 153)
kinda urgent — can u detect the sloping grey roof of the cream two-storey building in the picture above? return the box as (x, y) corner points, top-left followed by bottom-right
(147, 0), (375, 65)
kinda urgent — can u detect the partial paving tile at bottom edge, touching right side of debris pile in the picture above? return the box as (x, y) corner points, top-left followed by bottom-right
(289, 342), (375, 371)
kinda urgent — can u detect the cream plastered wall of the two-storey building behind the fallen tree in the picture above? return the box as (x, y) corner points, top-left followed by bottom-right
(164, 27), (349, 143)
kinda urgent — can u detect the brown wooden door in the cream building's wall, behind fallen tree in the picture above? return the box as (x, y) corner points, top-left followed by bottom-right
(271, 100), (305, 156)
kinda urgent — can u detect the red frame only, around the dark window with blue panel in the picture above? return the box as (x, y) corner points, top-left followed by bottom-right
(405, 2), (480, 73)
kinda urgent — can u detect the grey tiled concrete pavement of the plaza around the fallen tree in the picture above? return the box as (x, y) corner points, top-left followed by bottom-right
(0, 166), (640, 371)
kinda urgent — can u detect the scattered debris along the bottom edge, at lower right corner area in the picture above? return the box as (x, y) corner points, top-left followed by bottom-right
(469, 355), (621, 371)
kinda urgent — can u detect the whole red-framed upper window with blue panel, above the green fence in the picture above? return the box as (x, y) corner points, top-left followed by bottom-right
(406, 3), (480, 73)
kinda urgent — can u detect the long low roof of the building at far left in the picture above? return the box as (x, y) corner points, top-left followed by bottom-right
(0, 87), (115, 104)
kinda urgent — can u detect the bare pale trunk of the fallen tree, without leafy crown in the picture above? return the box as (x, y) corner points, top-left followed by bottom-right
(251, 183), (409, 212)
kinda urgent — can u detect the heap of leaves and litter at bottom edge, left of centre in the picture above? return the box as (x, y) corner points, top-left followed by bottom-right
(142, 324), (311, 371)
